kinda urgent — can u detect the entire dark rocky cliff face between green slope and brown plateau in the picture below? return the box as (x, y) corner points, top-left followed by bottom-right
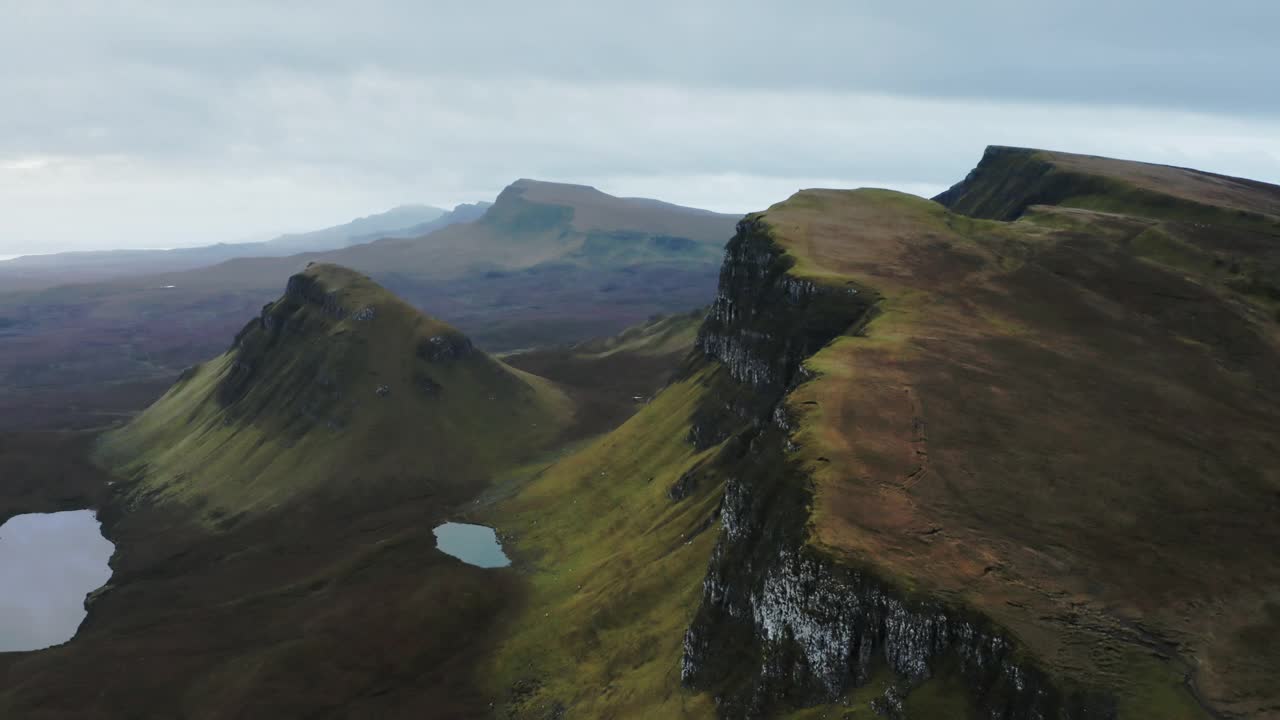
(681, 217), (1115, 720)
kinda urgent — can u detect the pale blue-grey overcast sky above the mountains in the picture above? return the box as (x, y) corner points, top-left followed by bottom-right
(0, 0), (1280, 256)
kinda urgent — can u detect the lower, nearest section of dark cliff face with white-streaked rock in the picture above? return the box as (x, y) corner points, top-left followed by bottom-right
(681, 445), (1116, 720)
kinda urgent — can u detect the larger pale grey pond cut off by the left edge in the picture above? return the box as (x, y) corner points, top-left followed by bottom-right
(0, 510), (114, 652)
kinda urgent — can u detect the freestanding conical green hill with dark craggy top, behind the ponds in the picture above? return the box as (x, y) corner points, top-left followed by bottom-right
(102, 264), (571, 519)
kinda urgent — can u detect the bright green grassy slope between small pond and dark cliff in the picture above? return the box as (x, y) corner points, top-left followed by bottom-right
(476, 368), (721, 717)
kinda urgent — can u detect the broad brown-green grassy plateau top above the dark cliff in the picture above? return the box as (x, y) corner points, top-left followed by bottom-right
(756, 161), (1280, 717)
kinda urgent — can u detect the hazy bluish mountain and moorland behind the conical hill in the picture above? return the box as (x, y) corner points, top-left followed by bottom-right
(0, 181), (737, 428)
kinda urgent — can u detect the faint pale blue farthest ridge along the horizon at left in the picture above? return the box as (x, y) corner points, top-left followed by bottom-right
(0, 205), (455, 291)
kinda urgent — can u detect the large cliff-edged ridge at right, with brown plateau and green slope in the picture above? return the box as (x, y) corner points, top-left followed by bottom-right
(477, 147), (1280, 720)
